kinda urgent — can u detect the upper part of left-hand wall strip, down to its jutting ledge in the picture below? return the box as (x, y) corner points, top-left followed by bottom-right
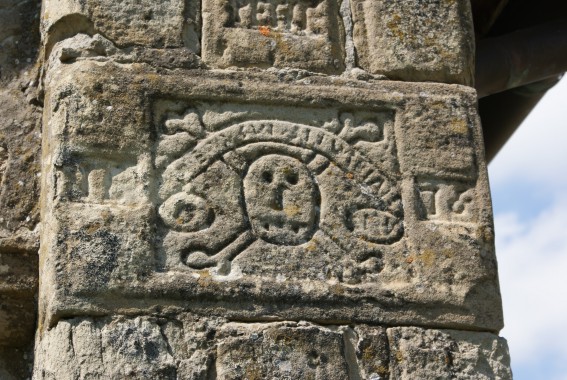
(0, 1), (41, 251)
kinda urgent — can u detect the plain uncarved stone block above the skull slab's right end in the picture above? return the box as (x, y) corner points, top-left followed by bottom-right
(351, 0), (474, 86)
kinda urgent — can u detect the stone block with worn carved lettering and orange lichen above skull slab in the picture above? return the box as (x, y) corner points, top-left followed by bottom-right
(203, 0), (345, 73)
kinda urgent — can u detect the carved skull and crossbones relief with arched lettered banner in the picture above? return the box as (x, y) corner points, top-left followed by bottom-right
(156, 105), (403, 274)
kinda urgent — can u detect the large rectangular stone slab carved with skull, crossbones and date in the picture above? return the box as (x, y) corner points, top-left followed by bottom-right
(41, 61), (502, 331)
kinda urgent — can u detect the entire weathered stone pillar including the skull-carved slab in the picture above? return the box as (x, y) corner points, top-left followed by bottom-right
(0, 0), (511, 380)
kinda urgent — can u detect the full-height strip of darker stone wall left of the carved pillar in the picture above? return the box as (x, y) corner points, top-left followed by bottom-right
(0, 0), (41, 379)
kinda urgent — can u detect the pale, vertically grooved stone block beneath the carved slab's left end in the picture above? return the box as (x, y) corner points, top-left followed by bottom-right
(34, 317), (177, 380)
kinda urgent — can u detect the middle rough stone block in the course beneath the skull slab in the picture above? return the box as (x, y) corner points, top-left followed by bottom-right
(216, 323), (349, 380)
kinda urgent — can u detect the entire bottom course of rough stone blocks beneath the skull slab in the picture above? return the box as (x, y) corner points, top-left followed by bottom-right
(34, 314), (511, 380)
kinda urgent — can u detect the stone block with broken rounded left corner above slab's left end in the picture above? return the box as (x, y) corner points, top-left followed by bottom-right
(42, 0), (201, 53)
